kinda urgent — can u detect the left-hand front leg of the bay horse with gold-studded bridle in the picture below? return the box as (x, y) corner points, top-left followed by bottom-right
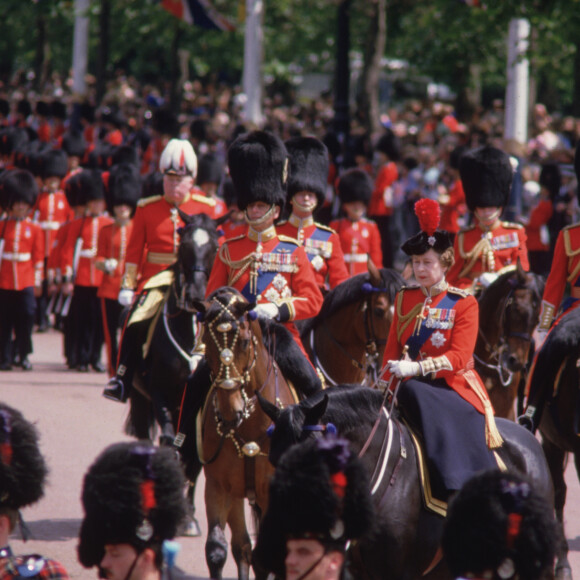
(205, 473), (231, 580)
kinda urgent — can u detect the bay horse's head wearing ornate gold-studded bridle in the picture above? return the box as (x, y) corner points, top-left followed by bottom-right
(195, 286), (261, 428)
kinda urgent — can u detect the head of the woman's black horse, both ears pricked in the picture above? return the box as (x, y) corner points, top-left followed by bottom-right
(257, 393), (332, 466)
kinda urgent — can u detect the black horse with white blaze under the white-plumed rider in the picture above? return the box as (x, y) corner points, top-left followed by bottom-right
(126, 211), (220, 535)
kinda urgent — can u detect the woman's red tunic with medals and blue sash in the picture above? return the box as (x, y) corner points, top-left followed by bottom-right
(383, 281), (488, 413)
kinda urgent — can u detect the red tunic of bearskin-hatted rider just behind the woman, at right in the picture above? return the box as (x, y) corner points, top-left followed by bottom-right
(447, 222), (530, 288)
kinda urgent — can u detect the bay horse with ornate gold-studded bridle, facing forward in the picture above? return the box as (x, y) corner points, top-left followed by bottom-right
(193, 286), (298, 580)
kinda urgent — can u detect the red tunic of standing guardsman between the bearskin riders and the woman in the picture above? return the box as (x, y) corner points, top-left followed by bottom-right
(330, 218), (383, 276)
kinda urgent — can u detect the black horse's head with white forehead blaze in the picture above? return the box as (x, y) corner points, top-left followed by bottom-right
(175, 210), (218, 312)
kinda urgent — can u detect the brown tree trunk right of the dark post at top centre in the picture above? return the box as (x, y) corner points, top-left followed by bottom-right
(359, 0), (387, 134)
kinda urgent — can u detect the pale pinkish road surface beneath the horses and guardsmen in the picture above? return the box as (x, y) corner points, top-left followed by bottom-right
(0, 331), (580, 580)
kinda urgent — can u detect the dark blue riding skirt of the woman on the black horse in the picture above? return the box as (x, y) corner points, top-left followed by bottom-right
(397, 379), (497, 498)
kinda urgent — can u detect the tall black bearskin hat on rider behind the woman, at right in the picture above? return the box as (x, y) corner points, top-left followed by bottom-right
(459, 145), (513, 211)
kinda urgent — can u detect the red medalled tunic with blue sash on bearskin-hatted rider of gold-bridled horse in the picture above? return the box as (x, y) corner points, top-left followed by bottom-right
(206, 226), (322, 344)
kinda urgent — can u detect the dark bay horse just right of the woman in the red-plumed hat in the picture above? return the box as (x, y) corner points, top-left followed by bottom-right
(473, 261), (544, 420)
